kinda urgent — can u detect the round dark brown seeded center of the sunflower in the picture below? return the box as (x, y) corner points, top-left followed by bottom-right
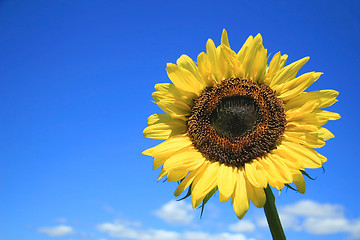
(187, 78), (286, 167)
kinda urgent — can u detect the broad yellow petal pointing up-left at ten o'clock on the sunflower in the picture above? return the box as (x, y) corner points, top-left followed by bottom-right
(166, 63), (203, 95)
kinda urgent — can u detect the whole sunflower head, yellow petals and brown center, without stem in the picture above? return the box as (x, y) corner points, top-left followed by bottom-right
(143, 30), (340, 219)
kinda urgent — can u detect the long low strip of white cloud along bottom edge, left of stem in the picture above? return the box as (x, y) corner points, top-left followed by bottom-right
(97, 221), (252, 240)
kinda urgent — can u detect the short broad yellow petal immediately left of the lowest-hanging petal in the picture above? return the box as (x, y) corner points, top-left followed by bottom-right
(218, 164), (236, 202)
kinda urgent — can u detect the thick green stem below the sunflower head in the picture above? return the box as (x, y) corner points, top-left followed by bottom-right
(264, 185), (286, 240)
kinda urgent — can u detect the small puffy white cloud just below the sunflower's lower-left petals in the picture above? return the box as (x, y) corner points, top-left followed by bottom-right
(154, 200), (194, 224)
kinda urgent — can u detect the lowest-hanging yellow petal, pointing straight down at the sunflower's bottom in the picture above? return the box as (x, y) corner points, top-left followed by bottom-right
(232, 169), (249, 219)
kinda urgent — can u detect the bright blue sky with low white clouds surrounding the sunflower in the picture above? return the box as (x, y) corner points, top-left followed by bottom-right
(0, 0), (360, 240)
